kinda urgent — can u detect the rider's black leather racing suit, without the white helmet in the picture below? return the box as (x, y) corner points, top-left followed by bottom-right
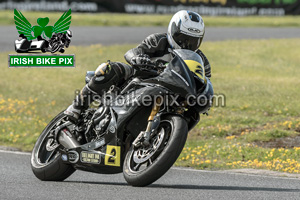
(73, 33), (211, 110)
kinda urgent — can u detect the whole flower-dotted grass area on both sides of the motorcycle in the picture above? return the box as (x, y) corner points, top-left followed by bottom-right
(0, 39), (300, 173)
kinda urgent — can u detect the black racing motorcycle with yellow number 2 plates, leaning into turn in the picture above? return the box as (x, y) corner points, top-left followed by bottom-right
(31, 49), (213, 186)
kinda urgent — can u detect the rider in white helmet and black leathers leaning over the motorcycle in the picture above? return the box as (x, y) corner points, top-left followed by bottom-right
(65, 10), (211, 121)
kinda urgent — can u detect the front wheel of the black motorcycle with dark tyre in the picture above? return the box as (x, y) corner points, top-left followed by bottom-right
(123, 115), (188, 186)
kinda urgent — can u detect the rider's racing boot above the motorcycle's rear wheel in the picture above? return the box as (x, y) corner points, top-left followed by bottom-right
(64, 85), (97, 123)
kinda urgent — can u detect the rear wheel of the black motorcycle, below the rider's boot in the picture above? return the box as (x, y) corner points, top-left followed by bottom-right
(31, 112), (75, 181)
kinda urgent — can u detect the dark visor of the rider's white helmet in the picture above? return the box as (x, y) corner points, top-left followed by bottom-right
(173, 32), (202, 51)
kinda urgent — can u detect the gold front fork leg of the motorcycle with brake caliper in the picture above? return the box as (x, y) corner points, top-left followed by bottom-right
(132, 97), (162, 148)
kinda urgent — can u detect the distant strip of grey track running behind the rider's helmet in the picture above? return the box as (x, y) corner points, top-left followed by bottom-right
(0, 26), (300, 51)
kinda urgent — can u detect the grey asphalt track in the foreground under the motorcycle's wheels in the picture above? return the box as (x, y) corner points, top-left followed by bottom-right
(0, 150), (300, 200)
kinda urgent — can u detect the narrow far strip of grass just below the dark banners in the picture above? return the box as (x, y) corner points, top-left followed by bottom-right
(0, 10), (300, 27)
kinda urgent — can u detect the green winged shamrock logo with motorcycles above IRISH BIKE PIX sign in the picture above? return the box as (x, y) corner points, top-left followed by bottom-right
(8, 9), (75, 68)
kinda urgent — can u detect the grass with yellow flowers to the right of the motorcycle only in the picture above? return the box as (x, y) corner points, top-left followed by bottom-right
(173, 39), (300, 173)
